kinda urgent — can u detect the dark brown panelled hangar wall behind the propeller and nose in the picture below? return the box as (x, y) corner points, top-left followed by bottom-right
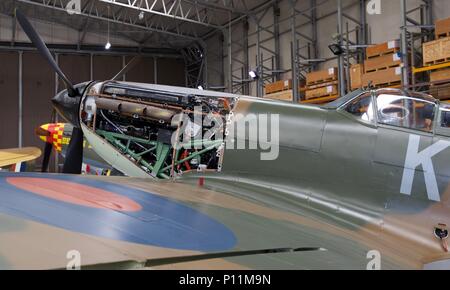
(0, 51), (185, 169)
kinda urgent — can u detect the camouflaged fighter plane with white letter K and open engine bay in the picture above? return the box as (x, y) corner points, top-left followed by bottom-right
(0, 11), (450, 269)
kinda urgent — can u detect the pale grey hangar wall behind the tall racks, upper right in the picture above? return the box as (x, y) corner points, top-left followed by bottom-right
(207, 0), (450, 95)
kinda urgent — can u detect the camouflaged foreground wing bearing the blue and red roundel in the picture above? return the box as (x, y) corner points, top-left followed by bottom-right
(0, 173), (408, 269)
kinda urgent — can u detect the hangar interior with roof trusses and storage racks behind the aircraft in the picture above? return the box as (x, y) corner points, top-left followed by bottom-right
(0, 0), (450, 171)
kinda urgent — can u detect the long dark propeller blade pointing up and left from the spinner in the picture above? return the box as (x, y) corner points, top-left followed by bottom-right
(15, 9), (78, 97)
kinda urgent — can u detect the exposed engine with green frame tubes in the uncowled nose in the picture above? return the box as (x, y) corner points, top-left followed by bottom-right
(80, 82), (236, 179)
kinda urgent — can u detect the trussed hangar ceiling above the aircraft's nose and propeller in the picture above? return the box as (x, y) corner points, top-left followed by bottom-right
(0, 0), (274, 49)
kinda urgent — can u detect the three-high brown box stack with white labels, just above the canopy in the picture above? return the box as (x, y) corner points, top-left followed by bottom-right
(362, 40), (402, 87)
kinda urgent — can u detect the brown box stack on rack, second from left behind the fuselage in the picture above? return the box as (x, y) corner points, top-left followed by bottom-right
(305, 67), (338, 100)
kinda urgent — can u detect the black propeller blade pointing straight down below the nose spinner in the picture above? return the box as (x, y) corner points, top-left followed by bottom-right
(63, 127), (84, 174)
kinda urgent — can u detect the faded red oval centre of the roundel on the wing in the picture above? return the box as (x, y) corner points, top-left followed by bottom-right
(6, 177), (142, 211)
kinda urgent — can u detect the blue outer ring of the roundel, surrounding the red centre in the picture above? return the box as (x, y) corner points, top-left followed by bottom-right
(0, 173), (236, 252)
